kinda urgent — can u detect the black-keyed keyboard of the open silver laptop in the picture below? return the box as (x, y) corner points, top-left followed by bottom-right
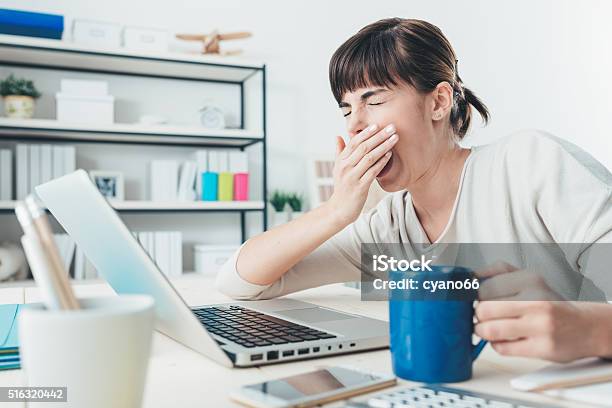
(192, 305), (336, 348)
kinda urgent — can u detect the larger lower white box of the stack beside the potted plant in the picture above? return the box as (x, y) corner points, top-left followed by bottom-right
(55, 93), (115, 125)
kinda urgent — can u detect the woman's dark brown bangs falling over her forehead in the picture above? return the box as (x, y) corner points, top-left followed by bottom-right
(329, 25), (413, 103)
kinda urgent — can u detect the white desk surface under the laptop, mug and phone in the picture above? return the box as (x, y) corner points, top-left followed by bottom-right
(0, 274), (587, 408)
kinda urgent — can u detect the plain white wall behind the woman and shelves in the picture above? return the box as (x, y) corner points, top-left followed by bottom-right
(0, 0), (612, 268)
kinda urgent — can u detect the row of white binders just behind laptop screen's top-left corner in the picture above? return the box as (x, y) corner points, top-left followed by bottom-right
(16, 144), (76, 200)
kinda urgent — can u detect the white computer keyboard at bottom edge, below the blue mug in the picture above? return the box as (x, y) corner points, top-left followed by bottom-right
(345, 385), (553, 408)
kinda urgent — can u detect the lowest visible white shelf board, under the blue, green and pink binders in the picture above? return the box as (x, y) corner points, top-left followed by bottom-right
(0, 201), (264, 211)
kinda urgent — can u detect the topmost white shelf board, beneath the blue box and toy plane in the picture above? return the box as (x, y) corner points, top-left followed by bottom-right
(0, 35), (264, 83)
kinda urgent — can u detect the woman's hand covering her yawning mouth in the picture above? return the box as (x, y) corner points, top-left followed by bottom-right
(327, 125), (399, 225)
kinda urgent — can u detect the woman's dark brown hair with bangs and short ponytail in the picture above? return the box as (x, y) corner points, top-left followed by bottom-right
(329, 18), (489, 139)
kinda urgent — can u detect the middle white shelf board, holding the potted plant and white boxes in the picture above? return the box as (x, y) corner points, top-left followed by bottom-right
(0, 118), (263, 146)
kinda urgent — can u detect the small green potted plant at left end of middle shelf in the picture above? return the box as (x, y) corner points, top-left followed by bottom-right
(0, 74), (40, 119)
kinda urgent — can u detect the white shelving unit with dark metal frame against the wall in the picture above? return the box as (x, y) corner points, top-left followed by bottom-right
(0, 35), (267, 272)
